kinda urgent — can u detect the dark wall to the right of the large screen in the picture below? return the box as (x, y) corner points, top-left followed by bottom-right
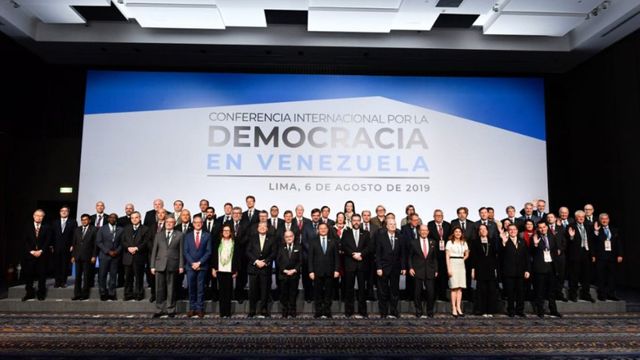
(546, 28), (640, 287)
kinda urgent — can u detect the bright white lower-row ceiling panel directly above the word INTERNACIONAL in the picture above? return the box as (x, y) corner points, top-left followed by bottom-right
(308, 8), (397, 33)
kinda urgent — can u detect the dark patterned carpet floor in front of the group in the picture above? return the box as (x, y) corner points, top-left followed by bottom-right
(0, 313), (640, 359)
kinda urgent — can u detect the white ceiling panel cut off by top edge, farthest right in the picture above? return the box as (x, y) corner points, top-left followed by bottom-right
(502, 0), (603, 14)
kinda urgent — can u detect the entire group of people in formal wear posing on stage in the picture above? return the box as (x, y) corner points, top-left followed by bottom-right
(22, 195), (623, 318)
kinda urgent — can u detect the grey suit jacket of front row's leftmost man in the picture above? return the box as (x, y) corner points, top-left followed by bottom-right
(149, 230), (185, 272)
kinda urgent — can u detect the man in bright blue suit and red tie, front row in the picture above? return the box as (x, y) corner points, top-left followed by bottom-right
(183, 216), (213, 318)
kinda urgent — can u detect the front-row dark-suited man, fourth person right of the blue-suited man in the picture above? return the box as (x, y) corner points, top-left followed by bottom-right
(308, 223), (340, 318)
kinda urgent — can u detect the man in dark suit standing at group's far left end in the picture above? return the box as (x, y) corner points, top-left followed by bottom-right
(22, 209), (52, 301)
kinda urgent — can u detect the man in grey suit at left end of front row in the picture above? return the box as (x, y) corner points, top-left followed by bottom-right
(150, 216), (184, 318)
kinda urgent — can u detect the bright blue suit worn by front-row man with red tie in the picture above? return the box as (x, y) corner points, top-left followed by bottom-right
(184, 229), (212, 311)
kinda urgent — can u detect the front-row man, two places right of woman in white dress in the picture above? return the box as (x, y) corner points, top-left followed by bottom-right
(500, 224), (531, 317)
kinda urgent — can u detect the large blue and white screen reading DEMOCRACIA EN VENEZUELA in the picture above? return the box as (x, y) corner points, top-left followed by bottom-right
(78, 71), (547, 219)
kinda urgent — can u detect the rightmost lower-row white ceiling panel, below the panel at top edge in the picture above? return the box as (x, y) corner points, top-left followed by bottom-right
(484, 13), (585, 36)
